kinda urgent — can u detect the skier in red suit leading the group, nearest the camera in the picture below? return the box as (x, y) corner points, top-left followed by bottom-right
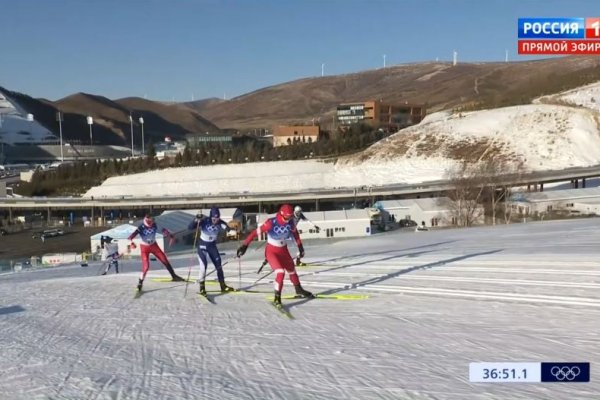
(237, 204), (314, 305)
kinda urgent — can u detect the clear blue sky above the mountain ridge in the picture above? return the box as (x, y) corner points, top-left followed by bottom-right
(0, 0), (600, 101)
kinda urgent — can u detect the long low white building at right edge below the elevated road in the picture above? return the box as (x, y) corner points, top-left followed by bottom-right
(509, 187), (600, 216)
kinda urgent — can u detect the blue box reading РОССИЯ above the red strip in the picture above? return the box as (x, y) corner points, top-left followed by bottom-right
(519, 18), (584, 39)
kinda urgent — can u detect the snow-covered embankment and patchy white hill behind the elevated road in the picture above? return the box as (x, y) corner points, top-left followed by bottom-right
(85, 83), (600, 198)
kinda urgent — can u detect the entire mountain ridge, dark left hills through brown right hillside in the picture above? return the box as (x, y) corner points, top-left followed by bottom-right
(0, 56), (600, 146)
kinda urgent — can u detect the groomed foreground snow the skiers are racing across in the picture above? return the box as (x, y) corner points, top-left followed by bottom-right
(0, 219), (600, 400)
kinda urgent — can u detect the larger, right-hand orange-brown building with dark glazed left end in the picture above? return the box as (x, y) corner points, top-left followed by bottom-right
(337, 101), (426, 129)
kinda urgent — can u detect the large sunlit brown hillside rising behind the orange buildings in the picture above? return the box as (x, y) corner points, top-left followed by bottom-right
(186, 56), (600, 129)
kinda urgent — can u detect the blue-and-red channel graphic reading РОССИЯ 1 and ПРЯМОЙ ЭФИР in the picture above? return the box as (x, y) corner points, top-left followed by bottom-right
(518, 18), (600, 54)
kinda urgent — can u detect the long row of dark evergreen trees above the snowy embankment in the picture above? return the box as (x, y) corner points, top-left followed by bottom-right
(15, 124), (386, 196)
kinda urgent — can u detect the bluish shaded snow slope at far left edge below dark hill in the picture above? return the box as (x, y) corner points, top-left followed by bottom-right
(0, 91), (58, 144)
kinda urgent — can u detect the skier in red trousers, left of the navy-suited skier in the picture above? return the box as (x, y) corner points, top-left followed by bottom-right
(128, 214), (184, 291)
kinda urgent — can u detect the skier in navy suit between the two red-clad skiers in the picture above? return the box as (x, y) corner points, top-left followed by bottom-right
(188, 207), (235, 296)
